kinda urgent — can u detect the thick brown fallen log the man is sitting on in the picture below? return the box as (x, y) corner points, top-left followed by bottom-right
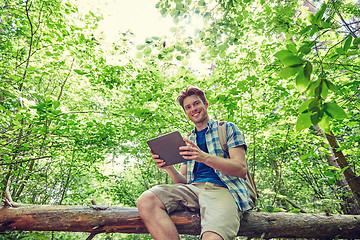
(0, 205), (360, 239)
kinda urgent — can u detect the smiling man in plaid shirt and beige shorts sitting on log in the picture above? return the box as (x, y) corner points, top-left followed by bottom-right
(137, 86), (253, 240)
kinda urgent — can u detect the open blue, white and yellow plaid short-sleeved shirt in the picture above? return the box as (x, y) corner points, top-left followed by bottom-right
(184, 119), (254, 211)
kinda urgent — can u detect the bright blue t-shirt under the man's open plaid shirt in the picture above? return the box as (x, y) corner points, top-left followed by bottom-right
(193, 128), (226, 188)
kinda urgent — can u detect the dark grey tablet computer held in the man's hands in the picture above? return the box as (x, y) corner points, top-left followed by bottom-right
(146, 131), (188, 166)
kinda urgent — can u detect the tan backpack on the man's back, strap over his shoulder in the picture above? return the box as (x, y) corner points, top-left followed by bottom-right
(218, 121), (259, 204)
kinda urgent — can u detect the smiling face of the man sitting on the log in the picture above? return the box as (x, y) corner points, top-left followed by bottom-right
(183, 95), (209, 123)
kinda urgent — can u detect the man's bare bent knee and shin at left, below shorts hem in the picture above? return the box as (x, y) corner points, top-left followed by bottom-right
(137, 191), (180, 240)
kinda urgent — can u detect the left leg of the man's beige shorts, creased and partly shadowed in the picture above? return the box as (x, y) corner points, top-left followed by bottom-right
(149, 184), (199, 213)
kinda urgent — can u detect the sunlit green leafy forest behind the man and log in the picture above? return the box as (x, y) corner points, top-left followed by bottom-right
(0, 0), (360, 239)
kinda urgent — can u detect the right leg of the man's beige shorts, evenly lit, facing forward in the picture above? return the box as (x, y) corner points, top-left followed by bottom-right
(199, 183), (242, 239)
